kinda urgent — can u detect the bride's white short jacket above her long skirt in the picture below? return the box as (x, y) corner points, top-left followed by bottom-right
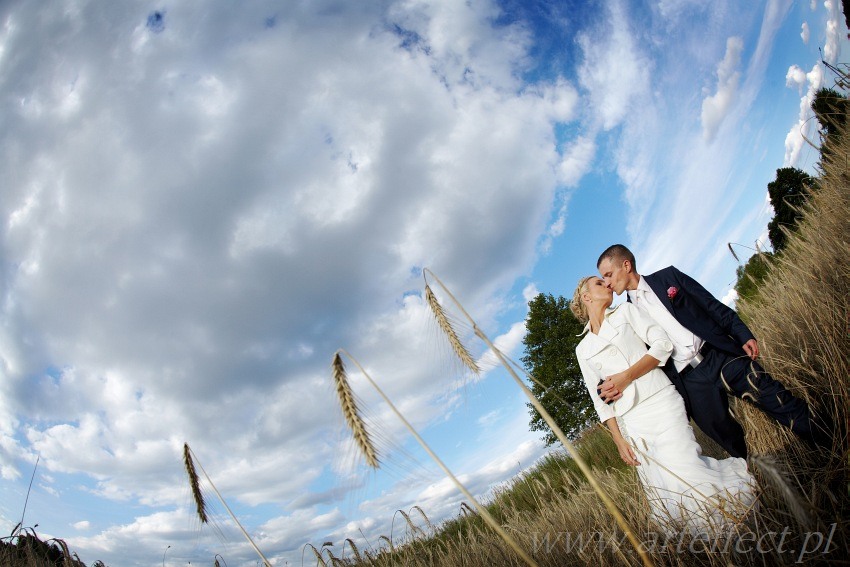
(576, 303), (673, 422)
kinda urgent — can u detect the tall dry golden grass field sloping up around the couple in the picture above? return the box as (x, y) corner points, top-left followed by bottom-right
(317, 104), (850, 567)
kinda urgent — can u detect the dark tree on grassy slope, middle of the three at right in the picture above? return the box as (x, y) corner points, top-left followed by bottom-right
(767, 167), (813, 252)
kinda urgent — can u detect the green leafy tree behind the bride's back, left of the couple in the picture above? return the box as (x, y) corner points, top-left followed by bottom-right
(522, 293), (597, 445)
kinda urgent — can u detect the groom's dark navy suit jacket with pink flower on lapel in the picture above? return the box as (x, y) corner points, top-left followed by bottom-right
(643, 266), (755, 356)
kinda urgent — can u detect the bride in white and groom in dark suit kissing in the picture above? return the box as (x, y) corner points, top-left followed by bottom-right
(570, 244), (831, 535)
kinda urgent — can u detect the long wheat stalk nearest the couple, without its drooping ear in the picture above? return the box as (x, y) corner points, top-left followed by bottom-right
(422, 268), (653, 567)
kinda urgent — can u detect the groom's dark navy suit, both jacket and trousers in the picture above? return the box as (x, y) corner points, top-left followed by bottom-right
(643, 266), (814, 457)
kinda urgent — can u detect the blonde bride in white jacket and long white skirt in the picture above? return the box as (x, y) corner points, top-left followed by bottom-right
(570, 276), (755, 535)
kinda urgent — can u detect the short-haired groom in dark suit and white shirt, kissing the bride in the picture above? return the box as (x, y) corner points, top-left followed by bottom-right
(596, 244), (820, 458)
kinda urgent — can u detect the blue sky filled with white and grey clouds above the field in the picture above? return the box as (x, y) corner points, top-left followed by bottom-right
(0, 0), (848, 567)
